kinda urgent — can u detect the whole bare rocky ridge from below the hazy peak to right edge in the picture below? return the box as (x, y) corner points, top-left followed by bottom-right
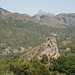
(33, 13), (75, 28)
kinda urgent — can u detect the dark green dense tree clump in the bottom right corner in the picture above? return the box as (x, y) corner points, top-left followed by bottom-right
(53, 56), (75, 75)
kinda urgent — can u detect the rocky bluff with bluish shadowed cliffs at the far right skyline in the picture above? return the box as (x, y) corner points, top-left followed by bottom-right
(56, 13), (75, 26)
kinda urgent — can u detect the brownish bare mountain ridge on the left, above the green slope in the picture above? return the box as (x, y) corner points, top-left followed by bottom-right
(0, 8), (37, 23)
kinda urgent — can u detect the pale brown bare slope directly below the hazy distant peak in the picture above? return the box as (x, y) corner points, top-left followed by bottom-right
(34, 16), (67, 28)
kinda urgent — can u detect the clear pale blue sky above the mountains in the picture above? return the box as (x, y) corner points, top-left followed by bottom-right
(0, 0), (75, 16)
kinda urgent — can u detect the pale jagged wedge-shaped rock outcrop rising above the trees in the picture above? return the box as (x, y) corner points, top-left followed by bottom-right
(20, 38), (60, 60)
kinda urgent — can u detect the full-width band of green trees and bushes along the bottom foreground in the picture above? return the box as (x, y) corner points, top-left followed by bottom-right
(0, 54), (75, 75)
